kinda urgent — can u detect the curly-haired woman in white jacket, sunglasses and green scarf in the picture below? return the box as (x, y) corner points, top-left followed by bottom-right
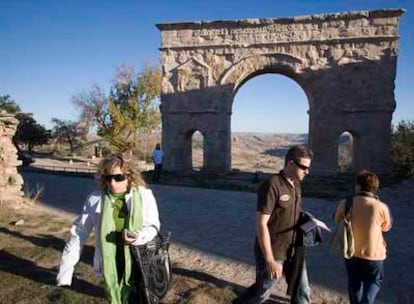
(57, 154), (160, 304)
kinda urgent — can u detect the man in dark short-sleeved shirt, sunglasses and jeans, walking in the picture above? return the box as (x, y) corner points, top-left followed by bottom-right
(233, 145), (313, 304)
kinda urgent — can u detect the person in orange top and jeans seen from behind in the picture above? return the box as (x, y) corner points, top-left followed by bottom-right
(335, 170), (392, 304)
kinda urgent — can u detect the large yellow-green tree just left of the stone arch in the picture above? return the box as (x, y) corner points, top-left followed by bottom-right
(73, 65), (161, 151)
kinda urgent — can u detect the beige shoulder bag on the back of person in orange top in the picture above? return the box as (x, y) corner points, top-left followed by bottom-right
(329, 196), (355, 259)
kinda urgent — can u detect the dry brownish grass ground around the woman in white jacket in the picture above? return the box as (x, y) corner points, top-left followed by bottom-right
(0, 204), (239, 304)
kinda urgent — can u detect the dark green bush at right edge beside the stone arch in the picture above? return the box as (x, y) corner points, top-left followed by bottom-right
(391, 120), (414, 178)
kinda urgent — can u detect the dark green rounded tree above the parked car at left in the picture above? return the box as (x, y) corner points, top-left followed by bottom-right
(13, 113), (50, 152)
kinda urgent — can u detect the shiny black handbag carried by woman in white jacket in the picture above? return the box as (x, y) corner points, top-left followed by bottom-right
(131, 226), (172, 304)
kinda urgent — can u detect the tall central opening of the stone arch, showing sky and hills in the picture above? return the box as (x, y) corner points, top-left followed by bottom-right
(231, 73), (309, 173)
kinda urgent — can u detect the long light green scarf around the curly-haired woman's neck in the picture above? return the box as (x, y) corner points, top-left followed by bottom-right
(100, 187), (143, 304)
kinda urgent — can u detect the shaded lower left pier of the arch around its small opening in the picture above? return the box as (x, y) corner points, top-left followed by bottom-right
(160, 86), (232, 173)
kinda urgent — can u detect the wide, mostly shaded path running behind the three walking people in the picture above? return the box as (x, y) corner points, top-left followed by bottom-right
(22, 172), (414, 304)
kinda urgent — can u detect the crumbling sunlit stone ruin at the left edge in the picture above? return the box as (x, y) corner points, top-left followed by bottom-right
(0, 112), (23, 203)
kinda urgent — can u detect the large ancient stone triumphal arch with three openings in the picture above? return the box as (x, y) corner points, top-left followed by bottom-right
(157, 9), (404, 175)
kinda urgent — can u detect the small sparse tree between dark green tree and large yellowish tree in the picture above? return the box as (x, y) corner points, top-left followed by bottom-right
(52, 118), (88, 153)
